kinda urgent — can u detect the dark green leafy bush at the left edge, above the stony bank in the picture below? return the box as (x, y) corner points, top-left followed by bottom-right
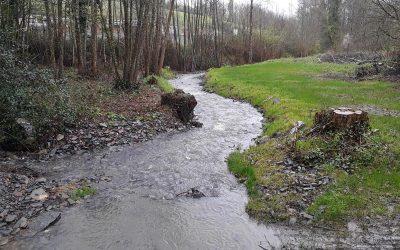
(0, 30), (76, 150)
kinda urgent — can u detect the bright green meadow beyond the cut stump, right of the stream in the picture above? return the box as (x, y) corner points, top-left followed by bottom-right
(207, 59), (400, 141)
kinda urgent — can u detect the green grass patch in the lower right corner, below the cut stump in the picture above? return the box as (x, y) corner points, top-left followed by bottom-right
(309, 169), (400, 221)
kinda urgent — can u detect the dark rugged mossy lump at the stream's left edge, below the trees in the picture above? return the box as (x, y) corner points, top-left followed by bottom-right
(161, 89), (197, 123)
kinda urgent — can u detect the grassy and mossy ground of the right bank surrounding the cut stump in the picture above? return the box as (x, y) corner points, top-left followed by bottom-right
(206, 58), (400, 224)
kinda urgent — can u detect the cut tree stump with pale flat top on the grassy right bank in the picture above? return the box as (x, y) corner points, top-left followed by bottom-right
(314, 107), (369, 136)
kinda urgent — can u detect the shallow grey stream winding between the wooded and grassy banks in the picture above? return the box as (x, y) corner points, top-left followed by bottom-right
(12, 74), (286, 249)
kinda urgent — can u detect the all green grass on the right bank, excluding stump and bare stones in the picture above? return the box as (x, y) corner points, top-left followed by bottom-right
(207, 58), (400, 225)
